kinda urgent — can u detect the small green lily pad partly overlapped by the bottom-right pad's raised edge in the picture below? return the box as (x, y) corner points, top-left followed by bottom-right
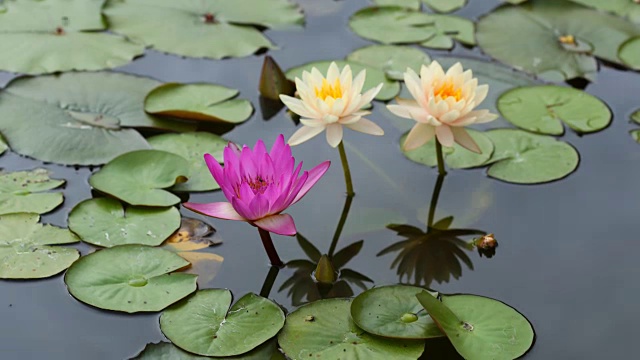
(351, 285), (444, 339)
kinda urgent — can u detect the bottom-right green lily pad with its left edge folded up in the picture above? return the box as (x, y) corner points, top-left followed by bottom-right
(417, 291), (535, 360)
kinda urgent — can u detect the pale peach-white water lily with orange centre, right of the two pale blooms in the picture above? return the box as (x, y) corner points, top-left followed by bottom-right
(387, 61), (498, 153)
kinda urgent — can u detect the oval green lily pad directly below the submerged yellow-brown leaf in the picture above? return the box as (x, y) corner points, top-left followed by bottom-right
(64, 245), (197, 313)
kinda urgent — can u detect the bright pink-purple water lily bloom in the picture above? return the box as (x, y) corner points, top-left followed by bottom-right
(183, 135), (330, 236)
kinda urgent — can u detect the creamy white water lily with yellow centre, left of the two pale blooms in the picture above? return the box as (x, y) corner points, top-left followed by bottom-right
(280, 62), (384, 147)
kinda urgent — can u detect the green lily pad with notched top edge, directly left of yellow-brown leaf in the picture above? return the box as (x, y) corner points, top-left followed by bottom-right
(69, 198), (180, 247)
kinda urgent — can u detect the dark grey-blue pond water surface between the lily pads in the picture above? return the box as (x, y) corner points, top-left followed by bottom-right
(0, 0), (640, 360)
